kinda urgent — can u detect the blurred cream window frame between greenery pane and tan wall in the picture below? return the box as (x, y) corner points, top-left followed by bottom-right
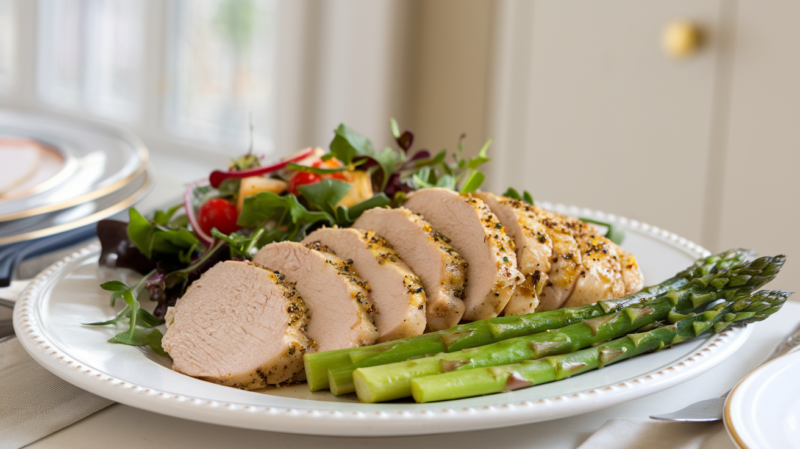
(276, 0), (416, 154)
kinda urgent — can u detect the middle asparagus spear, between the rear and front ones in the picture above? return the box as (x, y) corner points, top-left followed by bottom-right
(353, 256), (785, 402)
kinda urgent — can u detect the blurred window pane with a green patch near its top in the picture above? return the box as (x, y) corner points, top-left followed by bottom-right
(164, 0), (278, 152)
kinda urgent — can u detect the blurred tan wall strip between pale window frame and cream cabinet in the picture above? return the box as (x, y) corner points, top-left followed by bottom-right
(409, 0), (495, 159)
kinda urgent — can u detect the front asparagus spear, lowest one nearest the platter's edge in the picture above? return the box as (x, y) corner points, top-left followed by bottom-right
(411, 290), (790, 402)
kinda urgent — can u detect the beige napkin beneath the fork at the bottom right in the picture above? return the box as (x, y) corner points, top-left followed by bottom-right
(578, 419), (736, 449)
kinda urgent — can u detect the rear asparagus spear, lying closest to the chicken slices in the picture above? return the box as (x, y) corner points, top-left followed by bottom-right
(304, 249), (754, 394)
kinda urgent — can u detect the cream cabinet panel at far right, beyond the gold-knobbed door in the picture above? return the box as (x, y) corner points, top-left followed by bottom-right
(709, 0), (800, 294)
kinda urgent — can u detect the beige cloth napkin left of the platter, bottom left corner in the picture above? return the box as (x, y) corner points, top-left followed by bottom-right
(0, 338), (113, 449)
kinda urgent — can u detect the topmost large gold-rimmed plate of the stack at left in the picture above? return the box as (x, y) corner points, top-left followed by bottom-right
(0, 110), (148, 222)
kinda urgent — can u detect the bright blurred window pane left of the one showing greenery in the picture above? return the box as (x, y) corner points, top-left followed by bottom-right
(38, 0), (144, 120)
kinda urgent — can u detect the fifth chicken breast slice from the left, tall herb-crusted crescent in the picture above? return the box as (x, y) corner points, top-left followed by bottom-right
(404, 188), (523, 321)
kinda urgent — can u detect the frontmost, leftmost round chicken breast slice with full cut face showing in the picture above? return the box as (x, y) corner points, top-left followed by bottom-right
(161, 261), (310, 390)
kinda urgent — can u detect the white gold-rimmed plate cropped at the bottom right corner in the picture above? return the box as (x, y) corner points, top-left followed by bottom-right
(723, 351), (800, 449)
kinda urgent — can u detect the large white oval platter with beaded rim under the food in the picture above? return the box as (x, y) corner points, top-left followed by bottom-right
(14, 203), (750, 436)
